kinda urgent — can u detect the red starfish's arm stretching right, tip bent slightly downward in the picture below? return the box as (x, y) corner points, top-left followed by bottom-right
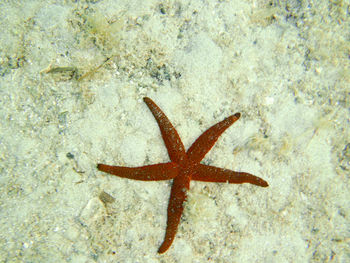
(191, 164), (269, 187)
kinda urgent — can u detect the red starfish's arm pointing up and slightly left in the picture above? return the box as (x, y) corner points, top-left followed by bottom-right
(143, 97), (186, 163)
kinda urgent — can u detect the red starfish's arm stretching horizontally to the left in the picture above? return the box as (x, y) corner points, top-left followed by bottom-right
(97, 162), (179, 181)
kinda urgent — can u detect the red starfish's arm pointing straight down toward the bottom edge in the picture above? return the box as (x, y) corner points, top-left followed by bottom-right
(158, 176), (190, 254)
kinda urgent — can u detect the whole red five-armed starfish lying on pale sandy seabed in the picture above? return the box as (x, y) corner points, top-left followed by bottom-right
(97, 97), (268, 253)
